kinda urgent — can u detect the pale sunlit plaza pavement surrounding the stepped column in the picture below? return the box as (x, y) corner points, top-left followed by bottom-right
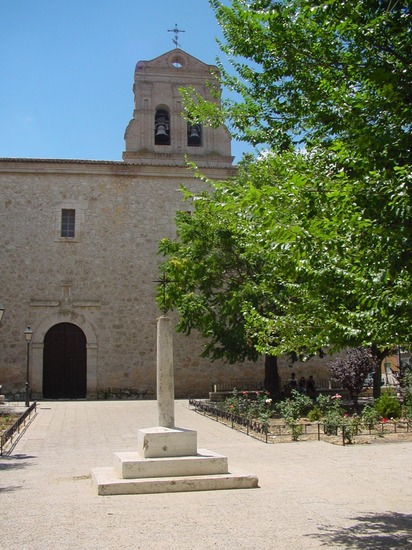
(0, 401), (412, 550)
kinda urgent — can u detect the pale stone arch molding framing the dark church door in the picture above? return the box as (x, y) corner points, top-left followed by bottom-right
(30, 311), (97, 399)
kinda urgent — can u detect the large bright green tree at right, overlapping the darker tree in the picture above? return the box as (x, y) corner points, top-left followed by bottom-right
(175, 0), (412, 396)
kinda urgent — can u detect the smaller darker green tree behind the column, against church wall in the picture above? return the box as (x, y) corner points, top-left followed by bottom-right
(157, 172), (281, 396)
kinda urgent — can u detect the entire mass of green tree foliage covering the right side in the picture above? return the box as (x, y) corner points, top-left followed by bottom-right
(158, 0), (412, 376)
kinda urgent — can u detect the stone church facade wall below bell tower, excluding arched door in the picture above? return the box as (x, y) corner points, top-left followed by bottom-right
(0, 160), (262, 398)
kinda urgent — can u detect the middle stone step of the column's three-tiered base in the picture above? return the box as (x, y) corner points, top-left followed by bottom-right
(113, 449), (228, 479)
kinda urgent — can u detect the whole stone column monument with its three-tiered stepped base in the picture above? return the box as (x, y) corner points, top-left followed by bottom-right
(92, 317), (258, 495)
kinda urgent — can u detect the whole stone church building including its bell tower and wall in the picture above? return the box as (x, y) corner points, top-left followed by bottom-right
(0, 48), (263, 399)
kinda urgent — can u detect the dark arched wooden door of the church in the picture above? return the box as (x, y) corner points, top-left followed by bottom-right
(43, 323), (87, 399)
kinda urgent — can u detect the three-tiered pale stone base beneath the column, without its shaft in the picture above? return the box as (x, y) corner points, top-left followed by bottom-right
(92, 427), (258, 495)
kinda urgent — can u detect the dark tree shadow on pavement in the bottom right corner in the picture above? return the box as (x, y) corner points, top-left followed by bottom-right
(309, 512), (412, 550)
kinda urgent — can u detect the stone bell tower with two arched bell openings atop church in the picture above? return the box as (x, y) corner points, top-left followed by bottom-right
(123, 48), (233, 168)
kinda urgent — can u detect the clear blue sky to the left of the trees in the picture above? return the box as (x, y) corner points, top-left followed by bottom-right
(0, 0), (253, 162)
